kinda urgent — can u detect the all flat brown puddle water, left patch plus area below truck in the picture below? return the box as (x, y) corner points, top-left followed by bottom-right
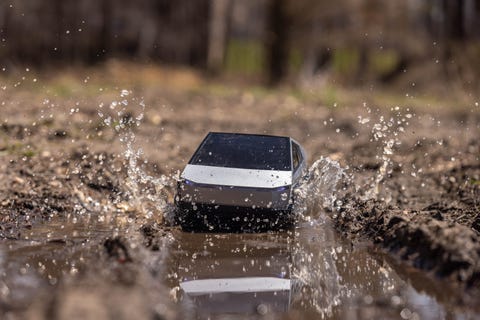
(0, 210), (480, 319)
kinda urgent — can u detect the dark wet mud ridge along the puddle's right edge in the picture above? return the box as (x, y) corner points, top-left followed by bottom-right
(335, 200), (480, 290)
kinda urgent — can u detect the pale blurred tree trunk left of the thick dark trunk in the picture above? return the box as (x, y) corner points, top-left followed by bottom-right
(207, 0), (232, 73)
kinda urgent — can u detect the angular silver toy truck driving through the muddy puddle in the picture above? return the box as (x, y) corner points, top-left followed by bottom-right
(175, 132), (306, 232)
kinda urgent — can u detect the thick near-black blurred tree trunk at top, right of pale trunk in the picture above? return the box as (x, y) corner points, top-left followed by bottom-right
(266, 0), (289, 85)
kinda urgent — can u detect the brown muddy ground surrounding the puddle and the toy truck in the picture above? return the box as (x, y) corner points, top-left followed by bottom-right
(0, 62), (480, 319)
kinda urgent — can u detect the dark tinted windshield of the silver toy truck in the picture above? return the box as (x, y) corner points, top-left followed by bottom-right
(190, 133), (291, 170)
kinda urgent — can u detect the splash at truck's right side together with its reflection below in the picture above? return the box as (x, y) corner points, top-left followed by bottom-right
(286, 157), (348, 319)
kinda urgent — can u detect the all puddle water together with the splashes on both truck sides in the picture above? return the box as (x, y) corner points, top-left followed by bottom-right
(0, 90), (480, 319)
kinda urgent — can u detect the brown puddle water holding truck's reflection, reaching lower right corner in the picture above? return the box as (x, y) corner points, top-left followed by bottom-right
(166, 221), (480, 319)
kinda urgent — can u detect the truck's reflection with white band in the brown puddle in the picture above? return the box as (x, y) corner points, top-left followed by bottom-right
(171, 233), (292, 318)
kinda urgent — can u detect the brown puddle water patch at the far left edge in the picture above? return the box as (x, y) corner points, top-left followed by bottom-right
(0, 212), (125, 319)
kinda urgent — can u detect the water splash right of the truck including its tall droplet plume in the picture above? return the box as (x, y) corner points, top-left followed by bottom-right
(294, 105), (414, 215)
